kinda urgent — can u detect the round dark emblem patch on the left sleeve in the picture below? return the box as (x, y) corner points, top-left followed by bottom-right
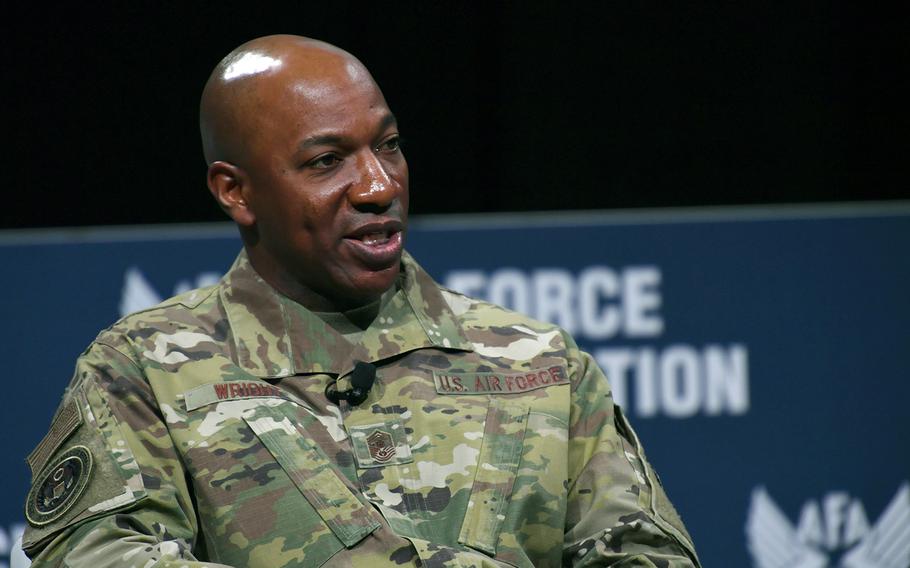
(25, 446), (92, 527)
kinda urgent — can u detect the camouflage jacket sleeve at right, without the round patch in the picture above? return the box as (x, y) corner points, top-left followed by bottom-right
(563, 339), (700, 568)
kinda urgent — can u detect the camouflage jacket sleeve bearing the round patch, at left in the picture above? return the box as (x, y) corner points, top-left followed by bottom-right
(23, 343), (232, 568)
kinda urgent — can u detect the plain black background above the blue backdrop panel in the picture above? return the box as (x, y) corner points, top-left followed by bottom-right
(0, 1), (910, 228)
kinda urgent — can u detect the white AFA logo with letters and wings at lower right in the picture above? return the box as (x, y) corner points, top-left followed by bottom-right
(746, 482), (910, 568)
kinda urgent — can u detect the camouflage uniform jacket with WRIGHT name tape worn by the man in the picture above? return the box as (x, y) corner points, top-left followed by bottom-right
(23, 253), (698, 568)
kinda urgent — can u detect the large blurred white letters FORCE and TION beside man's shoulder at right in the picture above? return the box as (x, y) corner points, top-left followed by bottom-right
(445, 266), (749, 418)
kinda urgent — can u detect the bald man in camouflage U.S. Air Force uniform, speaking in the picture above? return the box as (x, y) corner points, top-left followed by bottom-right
(23, 36), (698, 568)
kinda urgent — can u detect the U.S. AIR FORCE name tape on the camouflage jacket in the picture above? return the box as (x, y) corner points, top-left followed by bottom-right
(433, 366), (569, 394)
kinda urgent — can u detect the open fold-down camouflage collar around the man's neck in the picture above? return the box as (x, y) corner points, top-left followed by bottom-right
(219, 251), (472, 378)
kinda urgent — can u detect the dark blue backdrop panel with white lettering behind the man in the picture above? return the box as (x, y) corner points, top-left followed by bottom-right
(0, 203), (910, 568)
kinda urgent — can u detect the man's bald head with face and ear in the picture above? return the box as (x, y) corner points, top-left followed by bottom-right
(200, 35), (408, 311)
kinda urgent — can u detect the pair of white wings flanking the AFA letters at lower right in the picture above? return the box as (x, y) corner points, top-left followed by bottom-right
(746, 482), (910, 568)
